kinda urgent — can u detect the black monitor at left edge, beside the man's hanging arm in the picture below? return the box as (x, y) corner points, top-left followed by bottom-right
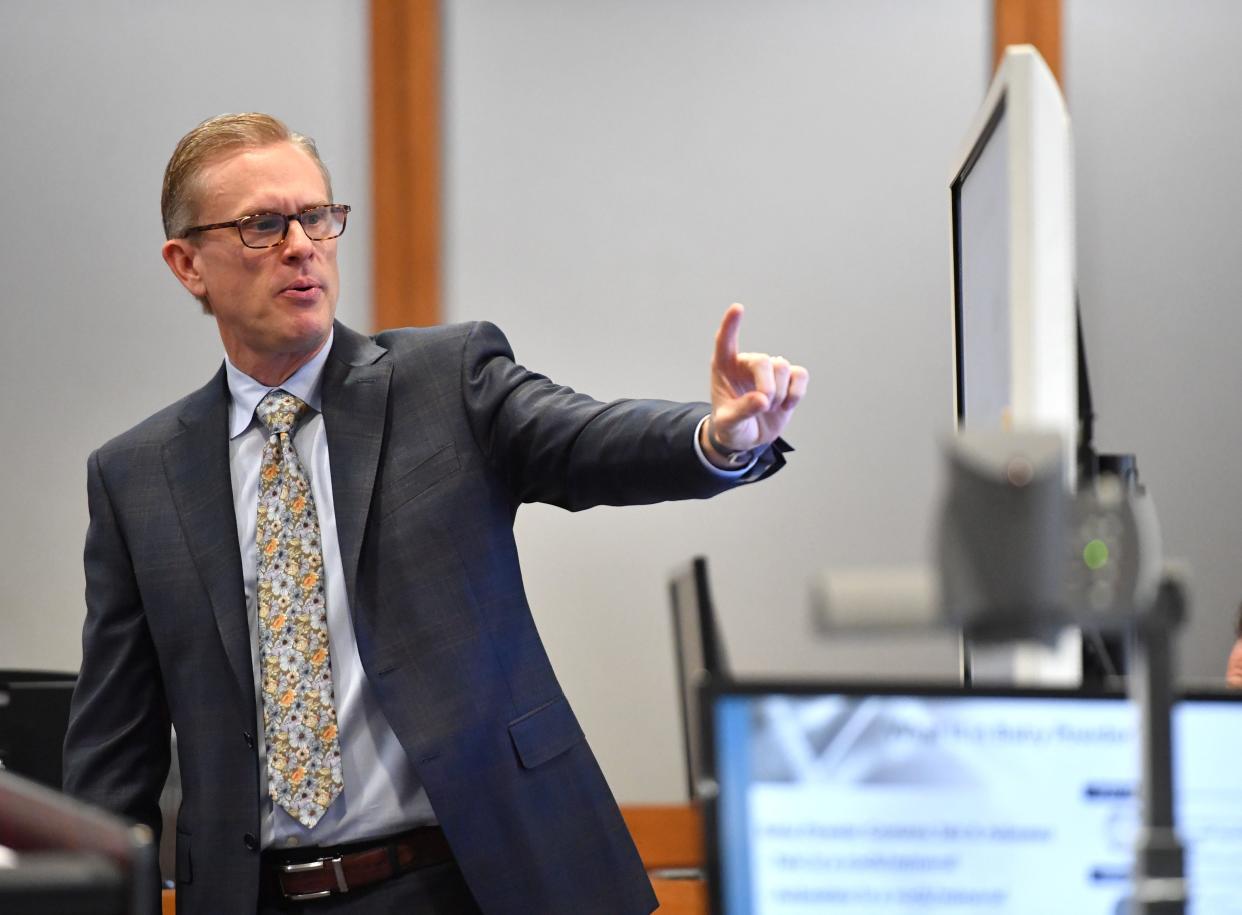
(0, 670), (77, 791)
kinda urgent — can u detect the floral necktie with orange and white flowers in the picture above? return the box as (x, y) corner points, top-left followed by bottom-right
(255, 390), (342, 828)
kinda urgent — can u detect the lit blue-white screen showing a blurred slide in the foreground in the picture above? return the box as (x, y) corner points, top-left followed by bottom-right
(703, 683), (1242, 915)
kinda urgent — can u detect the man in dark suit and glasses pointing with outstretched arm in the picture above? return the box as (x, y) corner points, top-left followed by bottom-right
(65, 114), (807, 915)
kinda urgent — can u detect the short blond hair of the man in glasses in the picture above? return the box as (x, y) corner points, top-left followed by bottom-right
(160, 112), (332, 238)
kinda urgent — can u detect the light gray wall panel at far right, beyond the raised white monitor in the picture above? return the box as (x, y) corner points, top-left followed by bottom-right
(1064, 0), (1242, 682)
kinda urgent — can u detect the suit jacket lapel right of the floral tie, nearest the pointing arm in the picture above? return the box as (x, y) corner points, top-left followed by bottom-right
(322, 323), (392, 607)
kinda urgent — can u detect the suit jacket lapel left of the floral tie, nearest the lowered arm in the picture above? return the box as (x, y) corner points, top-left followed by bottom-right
(164, 366), (255, 715)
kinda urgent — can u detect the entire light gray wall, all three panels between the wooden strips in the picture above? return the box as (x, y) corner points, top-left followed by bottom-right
(7, 0), (1242, 801)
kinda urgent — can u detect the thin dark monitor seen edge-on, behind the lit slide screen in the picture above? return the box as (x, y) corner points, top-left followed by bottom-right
(668, 556), (727, 800)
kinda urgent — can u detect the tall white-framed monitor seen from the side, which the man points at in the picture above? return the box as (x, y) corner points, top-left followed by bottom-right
(950, 45), (1078, 488)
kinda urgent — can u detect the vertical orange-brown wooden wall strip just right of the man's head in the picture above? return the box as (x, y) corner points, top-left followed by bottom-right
(370, 0), (441, 329)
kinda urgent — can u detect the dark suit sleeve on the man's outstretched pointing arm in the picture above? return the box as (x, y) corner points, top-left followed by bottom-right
(462, 322), (787, 510)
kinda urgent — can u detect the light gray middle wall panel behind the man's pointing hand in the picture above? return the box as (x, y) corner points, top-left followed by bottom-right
(446, 0), (990, 801)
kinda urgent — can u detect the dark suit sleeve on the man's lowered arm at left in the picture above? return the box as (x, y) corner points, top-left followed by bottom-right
(65, 452), (170, 841)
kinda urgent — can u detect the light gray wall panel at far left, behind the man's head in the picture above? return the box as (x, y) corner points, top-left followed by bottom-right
(0, 0), (370, 669)
